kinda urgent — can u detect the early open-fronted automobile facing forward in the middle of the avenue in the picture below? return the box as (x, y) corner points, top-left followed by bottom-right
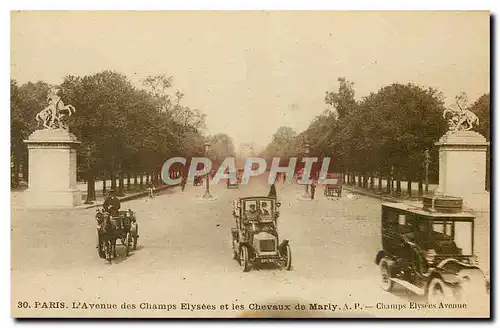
(231, 197), (292, 272)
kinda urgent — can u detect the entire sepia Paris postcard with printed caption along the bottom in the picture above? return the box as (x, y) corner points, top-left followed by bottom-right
(10, 11), (492, 318)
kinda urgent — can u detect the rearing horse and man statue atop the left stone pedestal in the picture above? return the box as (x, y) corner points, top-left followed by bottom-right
(36, 87), (76, 129)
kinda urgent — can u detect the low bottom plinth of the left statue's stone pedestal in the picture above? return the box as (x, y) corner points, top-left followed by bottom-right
(24, 189), (82, 208)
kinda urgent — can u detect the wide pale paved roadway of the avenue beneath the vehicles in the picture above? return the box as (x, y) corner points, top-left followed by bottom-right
(12, 178), (488, 317)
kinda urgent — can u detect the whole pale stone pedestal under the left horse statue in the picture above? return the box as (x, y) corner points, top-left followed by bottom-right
(24, 129), (82, 208)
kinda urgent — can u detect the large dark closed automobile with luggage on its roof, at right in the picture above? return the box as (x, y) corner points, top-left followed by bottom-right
(375, 197), (489, 303)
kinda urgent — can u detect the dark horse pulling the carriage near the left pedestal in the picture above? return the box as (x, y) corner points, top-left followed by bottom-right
(96, 210), (119, 263)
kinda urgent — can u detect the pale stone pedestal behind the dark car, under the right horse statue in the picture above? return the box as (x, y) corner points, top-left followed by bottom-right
(436, 131), (490, 211)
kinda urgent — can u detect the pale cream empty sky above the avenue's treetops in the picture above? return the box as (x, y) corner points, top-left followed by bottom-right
(11, 11), (490, 147)
